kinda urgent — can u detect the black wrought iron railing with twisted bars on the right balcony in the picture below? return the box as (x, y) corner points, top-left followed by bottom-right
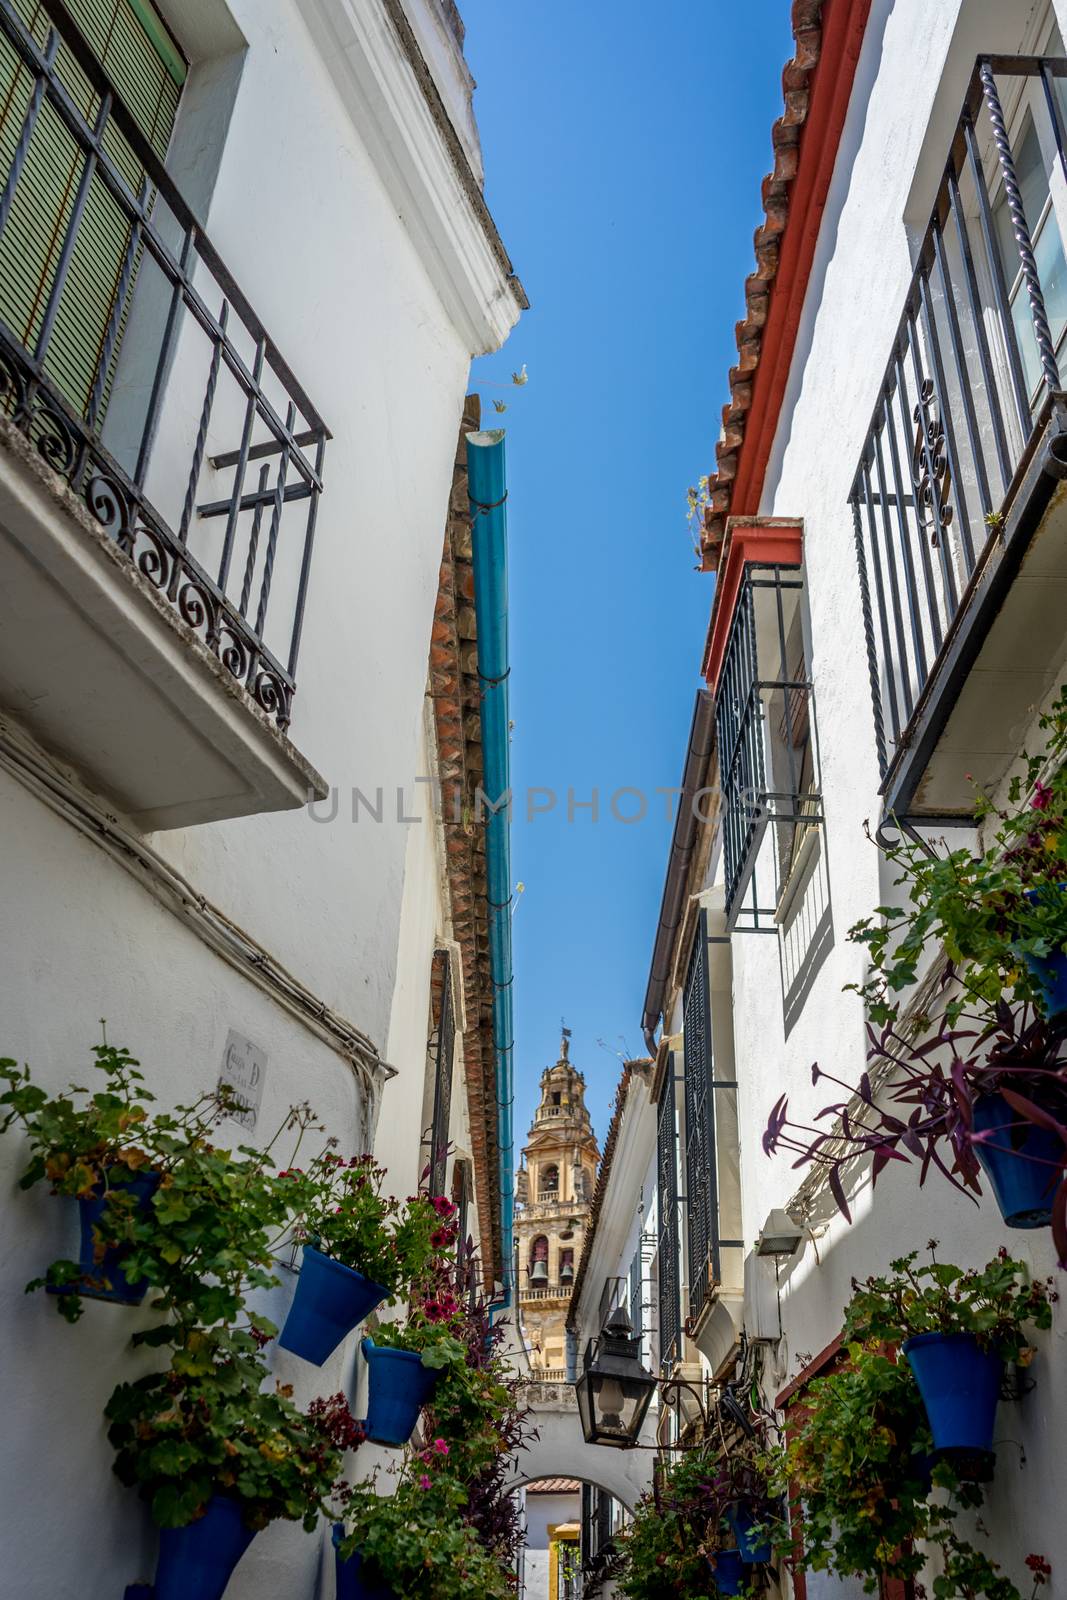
(851, 56), (1067, 792)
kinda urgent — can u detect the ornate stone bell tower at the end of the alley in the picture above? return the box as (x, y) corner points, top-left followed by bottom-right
(515, 1029), (600, 1379)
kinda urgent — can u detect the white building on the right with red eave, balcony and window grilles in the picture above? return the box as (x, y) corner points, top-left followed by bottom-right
(576, 0), (1067, 1600)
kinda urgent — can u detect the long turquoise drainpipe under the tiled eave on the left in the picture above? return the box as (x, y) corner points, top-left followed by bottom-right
(467, 429), (515, 1312)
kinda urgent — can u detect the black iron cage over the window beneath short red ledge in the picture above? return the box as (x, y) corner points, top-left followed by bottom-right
(715, 562), (822, 931)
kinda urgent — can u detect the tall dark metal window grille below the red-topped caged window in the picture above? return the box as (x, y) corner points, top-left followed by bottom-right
(683, 912), (720, 1317)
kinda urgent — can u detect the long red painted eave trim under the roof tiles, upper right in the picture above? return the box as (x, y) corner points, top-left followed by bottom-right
(729, 0), (870, 517)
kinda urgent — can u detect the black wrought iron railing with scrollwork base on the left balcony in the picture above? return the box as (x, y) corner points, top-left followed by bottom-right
(0, 0), (330, 726)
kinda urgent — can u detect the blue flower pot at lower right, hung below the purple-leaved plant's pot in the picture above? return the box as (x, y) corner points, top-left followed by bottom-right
(904, 1333), (1005, 1456)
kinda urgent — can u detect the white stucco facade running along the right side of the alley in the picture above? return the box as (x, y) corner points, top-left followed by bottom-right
(582, 0), (1067, 1600)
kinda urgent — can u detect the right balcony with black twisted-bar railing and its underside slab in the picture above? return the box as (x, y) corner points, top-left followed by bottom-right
(851, 56), (1067, 824)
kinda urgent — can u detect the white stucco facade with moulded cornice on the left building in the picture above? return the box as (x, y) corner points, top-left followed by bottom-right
(0, 0), (525, 1600)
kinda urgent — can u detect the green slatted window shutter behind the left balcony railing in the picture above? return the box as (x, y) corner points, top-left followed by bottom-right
(0, 0), (186, 426)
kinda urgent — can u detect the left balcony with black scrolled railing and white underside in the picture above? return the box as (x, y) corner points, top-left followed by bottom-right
(0, 0), (328, 829)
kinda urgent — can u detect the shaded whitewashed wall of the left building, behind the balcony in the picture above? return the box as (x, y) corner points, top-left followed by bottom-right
(0, 0), (517, 1600)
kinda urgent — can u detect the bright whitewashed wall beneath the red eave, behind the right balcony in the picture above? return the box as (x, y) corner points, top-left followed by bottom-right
(716, 0), (1067, 1595)
